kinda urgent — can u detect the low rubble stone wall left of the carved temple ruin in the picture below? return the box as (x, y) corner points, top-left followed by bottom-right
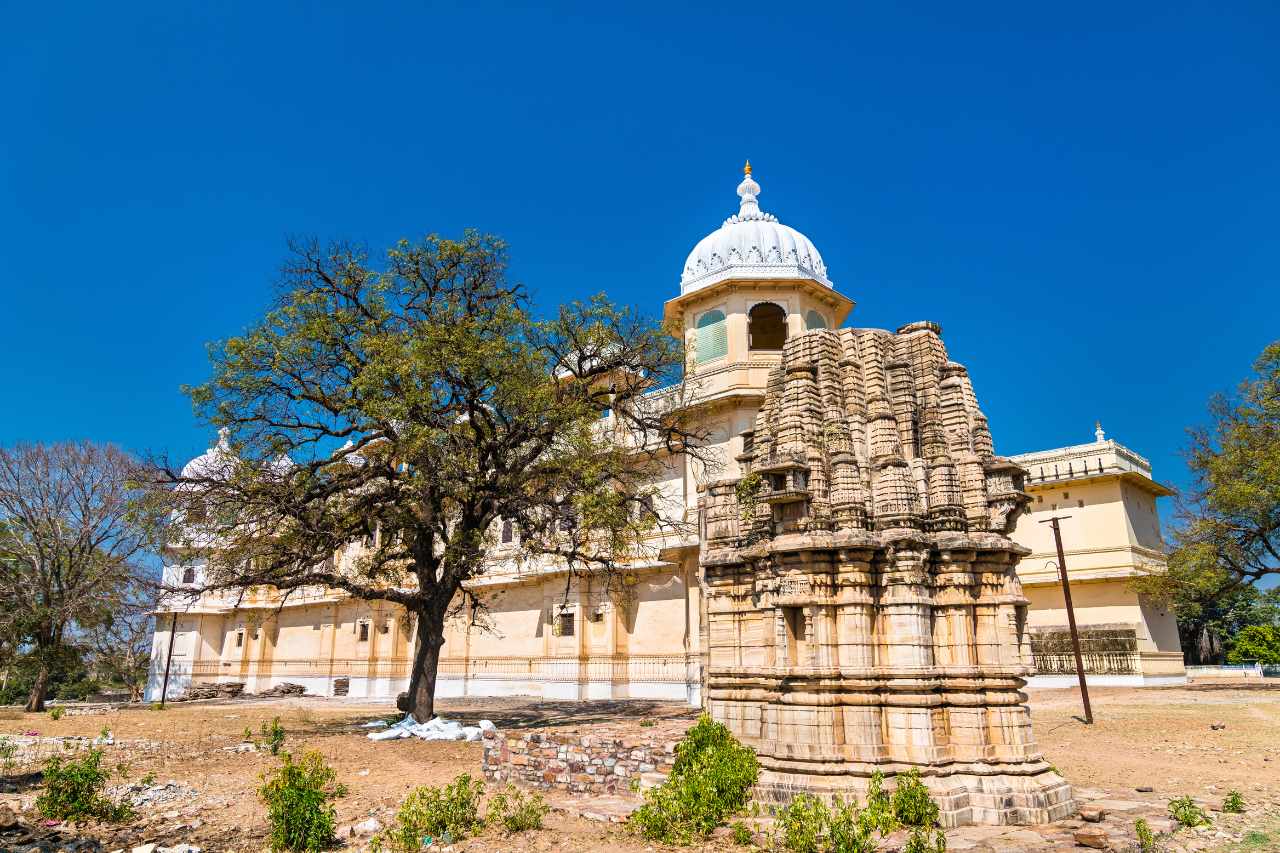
(484, 720), (691, 794)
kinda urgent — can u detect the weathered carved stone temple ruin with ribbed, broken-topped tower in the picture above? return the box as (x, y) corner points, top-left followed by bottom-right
(701, 323), (1074, 826)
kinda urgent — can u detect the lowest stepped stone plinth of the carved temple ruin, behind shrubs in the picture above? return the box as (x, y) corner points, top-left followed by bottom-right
(754, 765), (1076, 829)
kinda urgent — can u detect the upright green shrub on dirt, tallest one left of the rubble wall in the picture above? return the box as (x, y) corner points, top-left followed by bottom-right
(257, 752), (347, 853)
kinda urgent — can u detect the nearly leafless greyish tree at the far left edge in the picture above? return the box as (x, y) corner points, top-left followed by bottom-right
(0, 442), (164, 711)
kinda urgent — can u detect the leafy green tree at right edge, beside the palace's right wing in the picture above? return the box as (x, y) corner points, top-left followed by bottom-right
(1137, 342), (1280, 660)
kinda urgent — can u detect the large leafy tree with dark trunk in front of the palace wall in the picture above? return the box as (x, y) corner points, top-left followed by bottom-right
(164, 232), (695, 720)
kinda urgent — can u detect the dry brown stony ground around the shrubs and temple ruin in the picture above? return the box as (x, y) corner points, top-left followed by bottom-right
(0, 685), (1280, 853)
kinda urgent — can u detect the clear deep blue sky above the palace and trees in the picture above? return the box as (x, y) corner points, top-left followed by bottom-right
(0, 3), (1280, 504)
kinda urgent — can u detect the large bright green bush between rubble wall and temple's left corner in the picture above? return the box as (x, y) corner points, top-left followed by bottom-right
(628, 713), (760, 844)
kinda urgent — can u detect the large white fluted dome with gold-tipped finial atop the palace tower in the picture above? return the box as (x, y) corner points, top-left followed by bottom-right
(680, 163), (832, 293)
